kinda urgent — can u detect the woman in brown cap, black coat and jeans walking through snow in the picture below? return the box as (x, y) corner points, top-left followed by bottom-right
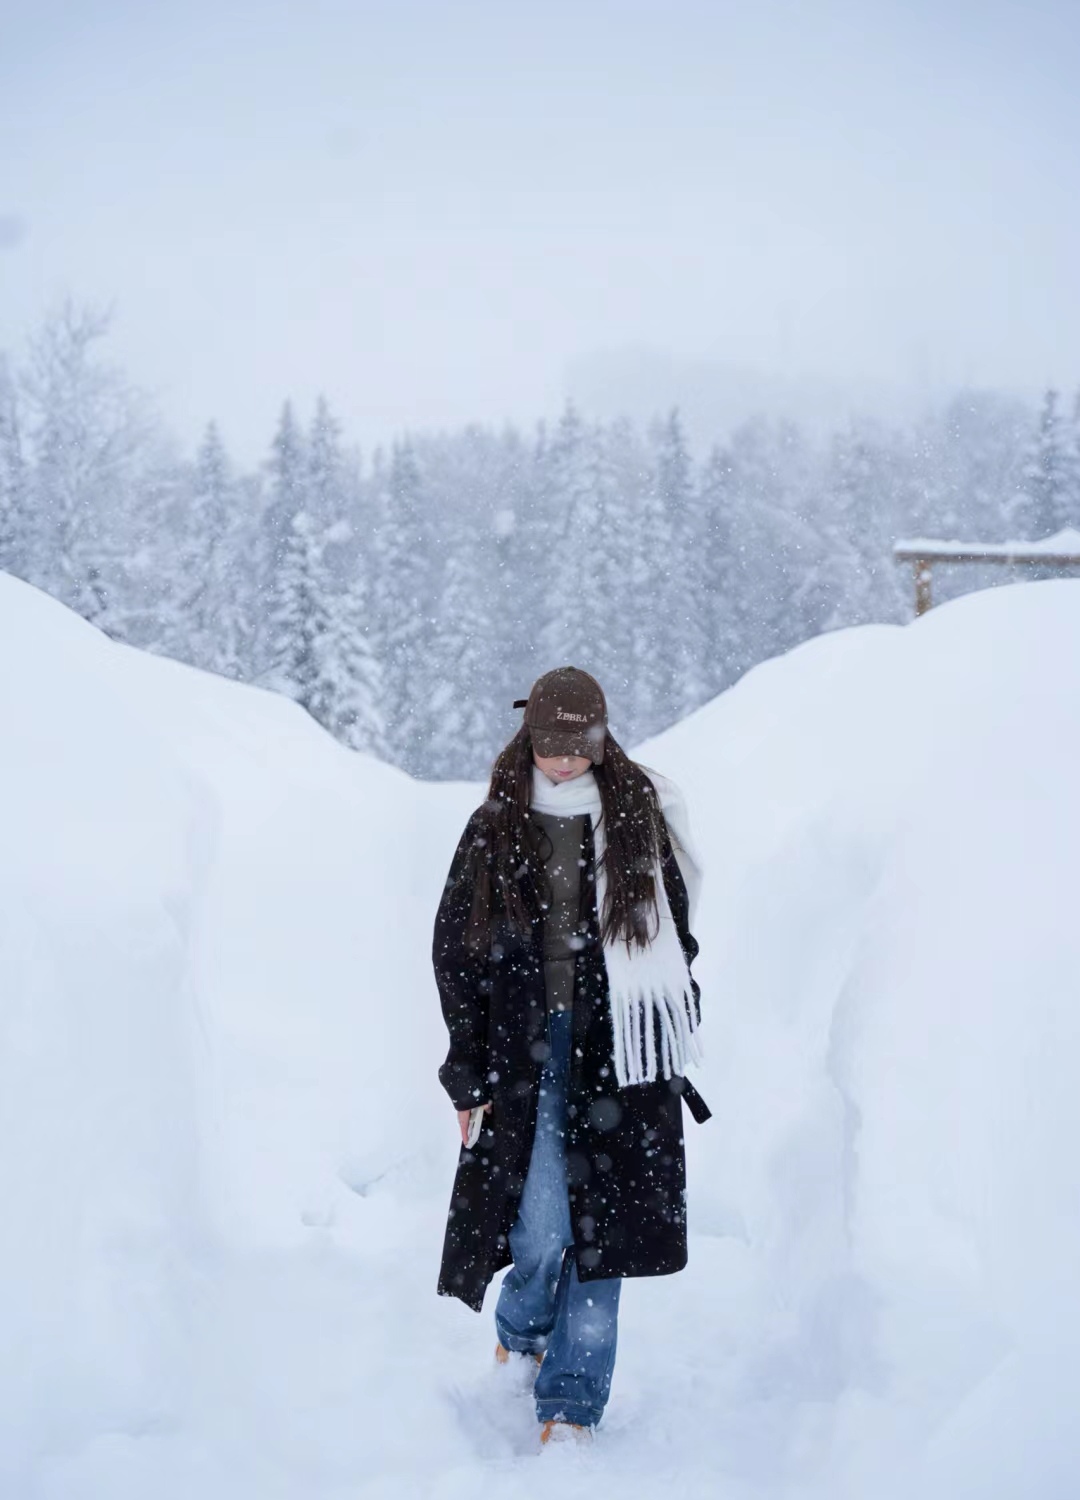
(434, 668), (710, 1442)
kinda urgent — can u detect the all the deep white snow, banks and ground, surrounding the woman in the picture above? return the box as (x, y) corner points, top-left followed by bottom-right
(0, 576), (1080, 1500)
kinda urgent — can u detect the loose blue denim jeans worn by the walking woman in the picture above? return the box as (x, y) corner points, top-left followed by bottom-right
(495, 1011), (623, 1427)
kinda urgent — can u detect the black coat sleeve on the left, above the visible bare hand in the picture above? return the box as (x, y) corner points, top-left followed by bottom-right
(432, 813), (491, 1110)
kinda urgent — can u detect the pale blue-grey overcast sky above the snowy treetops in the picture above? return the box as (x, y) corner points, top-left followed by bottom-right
(0, 0), (1080, 456)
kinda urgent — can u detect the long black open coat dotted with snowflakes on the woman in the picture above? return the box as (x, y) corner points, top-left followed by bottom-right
(434, 810), (710, 1313)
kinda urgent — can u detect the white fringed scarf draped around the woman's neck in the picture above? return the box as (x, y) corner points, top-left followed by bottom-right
(533, 767), (702, 1088)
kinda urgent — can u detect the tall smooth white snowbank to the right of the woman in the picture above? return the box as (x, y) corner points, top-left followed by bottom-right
(642, 582), (1080, 1500)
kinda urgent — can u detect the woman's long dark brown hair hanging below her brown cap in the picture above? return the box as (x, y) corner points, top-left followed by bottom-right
(464, 725), (665, 953)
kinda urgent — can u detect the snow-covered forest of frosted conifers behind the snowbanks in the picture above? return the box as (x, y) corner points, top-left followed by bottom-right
(0, 305), (1080, 779)
